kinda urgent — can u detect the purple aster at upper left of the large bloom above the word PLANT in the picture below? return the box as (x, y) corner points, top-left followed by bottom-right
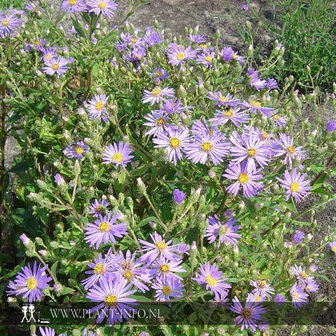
(81, 254), (114, 290)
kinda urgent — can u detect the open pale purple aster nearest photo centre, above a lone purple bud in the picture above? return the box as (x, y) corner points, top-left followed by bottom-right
(153, 127), (189, 166)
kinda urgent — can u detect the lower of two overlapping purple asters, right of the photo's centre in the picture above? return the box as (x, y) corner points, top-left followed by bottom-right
(223, 163), (263, 197)
